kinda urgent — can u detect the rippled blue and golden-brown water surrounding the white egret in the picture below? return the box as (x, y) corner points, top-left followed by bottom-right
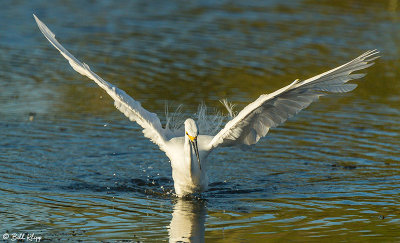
(0, 0), (400, 242)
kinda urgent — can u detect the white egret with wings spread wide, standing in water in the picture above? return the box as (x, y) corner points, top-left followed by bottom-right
(33, 15), (378, 196)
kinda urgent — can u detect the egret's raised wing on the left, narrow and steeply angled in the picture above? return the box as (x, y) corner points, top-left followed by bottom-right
(33, 15), (166, 150)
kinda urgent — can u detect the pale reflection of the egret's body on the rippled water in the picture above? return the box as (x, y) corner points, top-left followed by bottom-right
(169, 198), (207, 242)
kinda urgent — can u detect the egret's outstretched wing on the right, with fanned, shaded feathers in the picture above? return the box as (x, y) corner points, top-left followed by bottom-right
(210, 50), (379, 148)
